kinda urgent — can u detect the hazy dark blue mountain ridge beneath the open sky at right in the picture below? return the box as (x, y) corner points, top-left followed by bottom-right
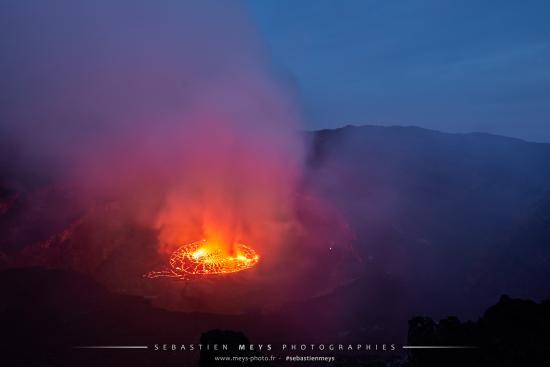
(304, 126), (550, 317)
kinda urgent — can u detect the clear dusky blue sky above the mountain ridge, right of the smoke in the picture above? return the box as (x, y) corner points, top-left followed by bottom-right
(246, 0), (550, 142)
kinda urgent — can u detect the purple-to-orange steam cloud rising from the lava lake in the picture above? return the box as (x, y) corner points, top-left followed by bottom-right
(0, 0), (303, 254)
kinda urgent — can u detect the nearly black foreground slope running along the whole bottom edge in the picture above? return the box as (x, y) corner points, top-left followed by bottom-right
(0, 268), (550, 367)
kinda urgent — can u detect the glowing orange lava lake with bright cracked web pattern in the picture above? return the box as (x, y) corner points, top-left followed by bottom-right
(145, 240), (260, 279)
